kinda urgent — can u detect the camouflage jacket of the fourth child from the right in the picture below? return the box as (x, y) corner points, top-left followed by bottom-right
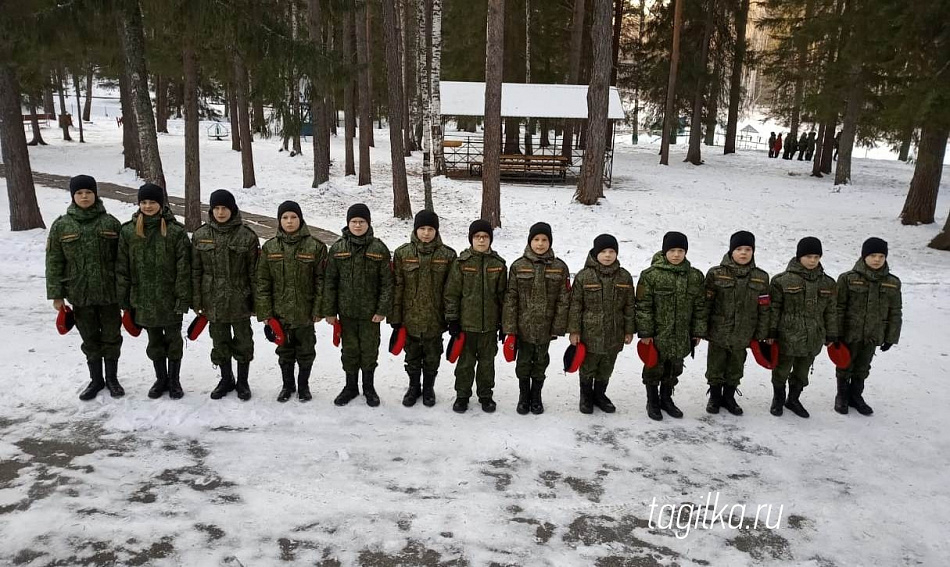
(637, 252), (707, 360)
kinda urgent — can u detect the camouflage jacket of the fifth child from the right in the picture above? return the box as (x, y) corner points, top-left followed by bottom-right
(567, 255), (637, 354)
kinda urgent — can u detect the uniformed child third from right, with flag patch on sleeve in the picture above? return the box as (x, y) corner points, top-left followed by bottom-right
(706, 230), (769, 415)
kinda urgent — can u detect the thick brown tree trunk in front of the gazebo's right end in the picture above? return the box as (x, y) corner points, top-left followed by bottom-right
(574, 0), (611, 205)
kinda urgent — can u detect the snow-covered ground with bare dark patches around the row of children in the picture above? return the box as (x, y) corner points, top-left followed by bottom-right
(0, 112), (950, 566)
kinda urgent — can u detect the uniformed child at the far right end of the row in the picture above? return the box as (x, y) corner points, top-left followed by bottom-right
(835, 238), (902, 415)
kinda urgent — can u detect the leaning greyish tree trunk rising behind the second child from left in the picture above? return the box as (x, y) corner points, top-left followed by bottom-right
(120, 0), (165, 188)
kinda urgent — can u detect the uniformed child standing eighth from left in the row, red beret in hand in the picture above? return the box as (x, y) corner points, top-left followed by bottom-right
(502, 222), (571, 415)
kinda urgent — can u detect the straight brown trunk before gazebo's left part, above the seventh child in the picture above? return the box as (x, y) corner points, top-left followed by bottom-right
(482, 0), (506, 228)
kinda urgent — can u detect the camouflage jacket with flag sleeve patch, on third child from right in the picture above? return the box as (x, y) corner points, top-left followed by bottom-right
(706, 254), (770, 350)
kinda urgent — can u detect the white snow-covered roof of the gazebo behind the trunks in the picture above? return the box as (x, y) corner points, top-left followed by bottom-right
(439, 81), (625, 120)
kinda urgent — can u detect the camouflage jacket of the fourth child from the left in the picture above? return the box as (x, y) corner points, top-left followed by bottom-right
(254, 222), (327, 327)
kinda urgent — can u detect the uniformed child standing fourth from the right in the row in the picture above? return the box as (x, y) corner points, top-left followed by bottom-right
(637, 232), (707, 420)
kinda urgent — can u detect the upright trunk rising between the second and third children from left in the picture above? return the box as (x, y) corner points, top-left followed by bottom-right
(181, 41), (201, 232)
